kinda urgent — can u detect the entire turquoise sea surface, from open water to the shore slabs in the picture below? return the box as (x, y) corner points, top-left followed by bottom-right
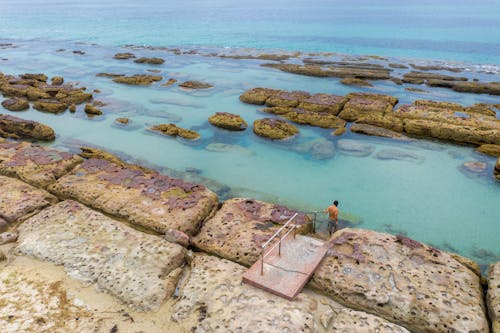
(0, 0), (500, 264)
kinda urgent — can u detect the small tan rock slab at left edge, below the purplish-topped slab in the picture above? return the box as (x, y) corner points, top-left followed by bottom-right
(0, 176), (57, 223)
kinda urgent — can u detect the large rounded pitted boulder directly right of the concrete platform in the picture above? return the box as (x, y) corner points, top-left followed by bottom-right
(313, 229), (488, 333)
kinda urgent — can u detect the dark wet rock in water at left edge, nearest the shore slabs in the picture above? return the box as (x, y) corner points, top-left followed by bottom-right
(0, 114), (56, 141)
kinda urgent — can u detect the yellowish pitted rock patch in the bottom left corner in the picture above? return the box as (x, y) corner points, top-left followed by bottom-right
(0, 269), (102, 333)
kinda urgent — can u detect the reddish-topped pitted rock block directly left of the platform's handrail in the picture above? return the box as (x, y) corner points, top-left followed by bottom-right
(192, 198), (310, 266)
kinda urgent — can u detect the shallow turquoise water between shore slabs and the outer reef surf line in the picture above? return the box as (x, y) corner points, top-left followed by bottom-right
(0, 40), (500, 264)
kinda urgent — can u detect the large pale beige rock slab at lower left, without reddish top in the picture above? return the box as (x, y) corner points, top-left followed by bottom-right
(17, 200), (185, 311)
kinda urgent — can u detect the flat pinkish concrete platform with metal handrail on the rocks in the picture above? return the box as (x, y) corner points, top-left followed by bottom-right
(243, 235), (327, 300)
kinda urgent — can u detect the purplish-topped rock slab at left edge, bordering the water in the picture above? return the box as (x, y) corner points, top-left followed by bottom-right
(0, 140), (82, 187)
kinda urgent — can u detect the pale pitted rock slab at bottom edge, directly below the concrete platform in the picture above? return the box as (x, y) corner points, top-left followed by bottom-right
(171, 254), (408, 333)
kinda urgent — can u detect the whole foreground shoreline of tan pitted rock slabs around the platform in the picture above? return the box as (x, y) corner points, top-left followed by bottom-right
(0, 141), (500, 332)
